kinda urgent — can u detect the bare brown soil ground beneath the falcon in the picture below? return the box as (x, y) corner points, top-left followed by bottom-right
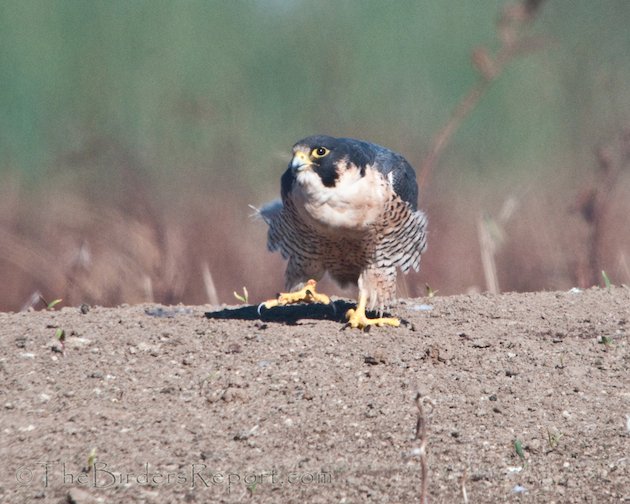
(0, 287), (630, 503)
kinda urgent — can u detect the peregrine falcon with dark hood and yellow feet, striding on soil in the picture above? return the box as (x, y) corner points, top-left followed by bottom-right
(260, 135), (427, 329)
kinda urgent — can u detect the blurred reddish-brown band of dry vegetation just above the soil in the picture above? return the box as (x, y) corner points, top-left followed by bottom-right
(0, 130), (630, 310)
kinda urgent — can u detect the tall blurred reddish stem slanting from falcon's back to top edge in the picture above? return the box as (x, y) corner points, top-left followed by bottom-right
(418, 0), (544, 189)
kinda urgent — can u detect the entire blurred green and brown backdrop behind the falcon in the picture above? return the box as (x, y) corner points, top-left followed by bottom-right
(0, 0), (630, 311)
